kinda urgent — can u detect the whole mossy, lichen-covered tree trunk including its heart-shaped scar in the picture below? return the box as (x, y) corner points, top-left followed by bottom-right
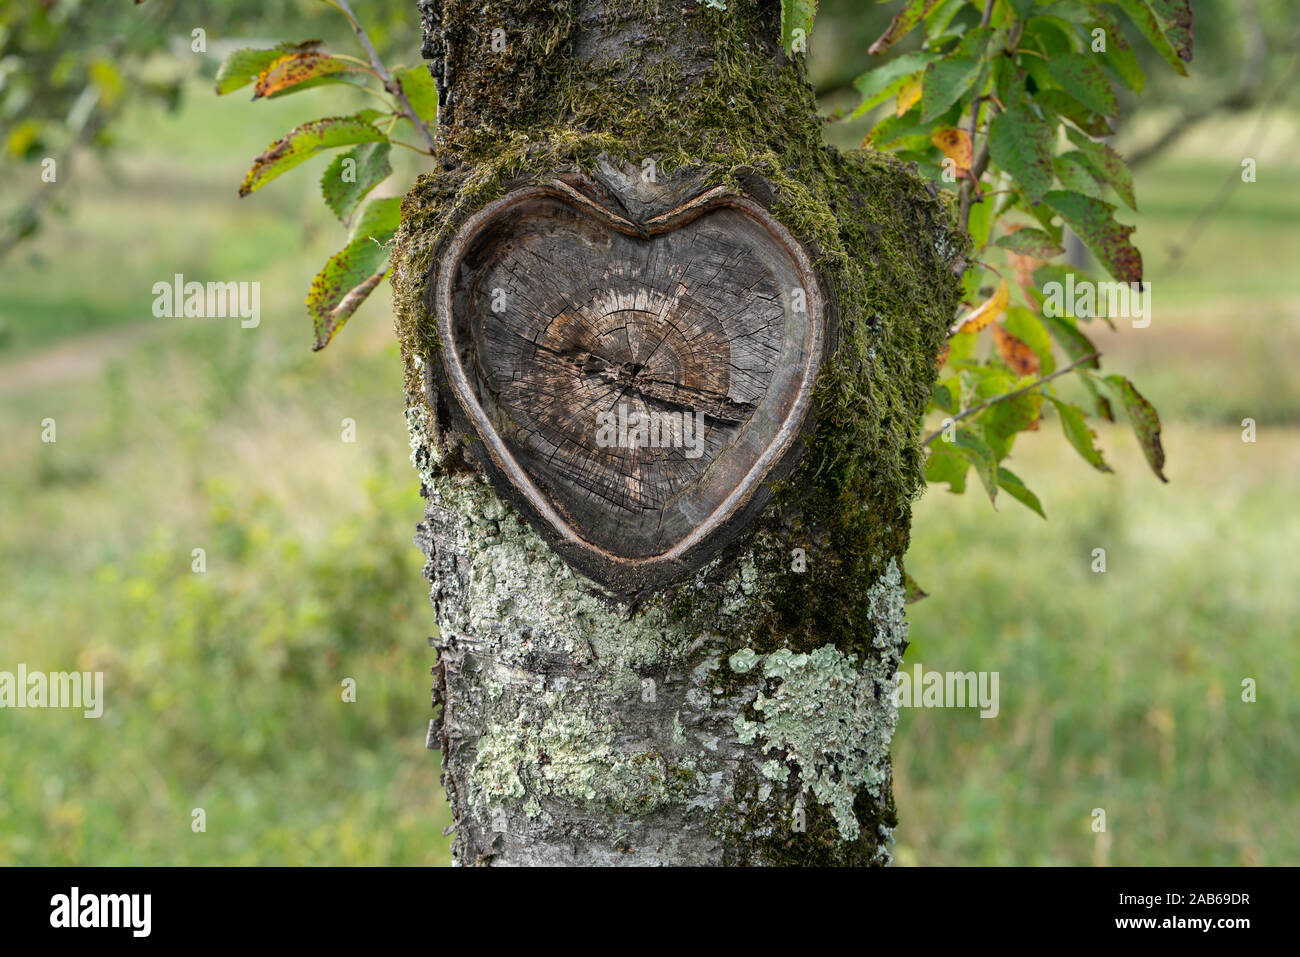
(394, 0), (966, 865)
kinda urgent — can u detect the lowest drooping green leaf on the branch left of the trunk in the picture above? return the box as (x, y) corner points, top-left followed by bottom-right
(307, 198), (402, 350)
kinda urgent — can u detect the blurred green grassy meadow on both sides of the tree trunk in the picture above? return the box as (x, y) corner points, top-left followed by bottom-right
(0, 70), (1300, 865)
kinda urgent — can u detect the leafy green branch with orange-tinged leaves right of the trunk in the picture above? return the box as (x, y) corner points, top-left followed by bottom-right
(816, 0), (1192, 514)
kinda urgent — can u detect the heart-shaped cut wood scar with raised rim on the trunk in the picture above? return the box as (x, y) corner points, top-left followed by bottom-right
(437, 174), (823, 592)
